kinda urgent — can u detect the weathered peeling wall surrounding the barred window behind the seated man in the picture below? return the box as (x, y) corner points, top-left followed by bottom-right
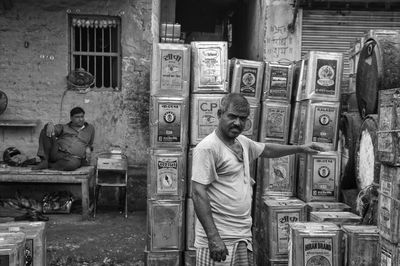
(0, 0), (154, 166)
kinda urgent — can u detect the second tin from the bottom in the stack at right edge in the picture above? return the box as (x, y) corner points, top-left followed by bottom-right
(378, 192), (400, 244)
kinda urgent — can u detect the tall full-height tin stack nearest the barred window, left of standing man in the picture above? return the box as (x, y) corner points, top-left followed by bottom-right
(145, 43), (191, 266)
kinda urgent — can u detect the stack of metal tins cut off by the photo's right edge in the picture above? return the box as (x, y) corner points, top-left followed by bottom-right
(377, 88), (400, 266)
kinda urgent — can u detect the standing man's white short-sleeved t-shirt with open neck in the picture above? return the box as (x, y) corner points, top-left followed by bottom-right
(192, 131), (265, 248)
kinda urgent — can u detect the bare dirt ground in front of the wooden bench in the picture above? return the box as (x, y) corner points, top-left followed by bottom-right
(42, 210), (146, 266)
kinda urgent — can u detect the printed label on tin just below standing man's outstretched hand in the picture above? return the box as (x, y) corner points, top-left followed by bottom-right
(312, 158), (337, 197)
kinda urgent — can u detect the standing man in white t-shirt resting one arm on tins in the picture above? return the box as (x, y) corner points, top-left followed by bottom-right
(192, 93), (322, 266)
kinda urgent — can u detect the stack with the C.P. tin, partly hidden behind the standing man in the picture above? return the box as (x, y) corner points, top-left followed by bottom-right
(184, 42), (230, 266)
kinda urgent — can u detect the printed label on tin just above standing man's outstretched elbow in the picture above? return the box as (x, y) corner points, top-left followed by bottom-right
(265, 106), (287, 140)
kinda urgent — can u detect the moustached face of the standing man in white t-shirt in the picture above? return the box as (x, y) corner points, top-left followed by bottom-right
(218, 104), (249, 139)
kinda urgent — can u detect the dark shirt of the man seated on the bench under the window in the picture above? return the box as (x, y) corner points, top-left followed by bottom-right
(54, 122), (95, 158)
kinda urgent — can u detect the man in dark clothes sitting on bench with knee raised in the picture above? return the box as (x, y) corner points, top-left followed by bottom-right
(32, 107), (95, 171)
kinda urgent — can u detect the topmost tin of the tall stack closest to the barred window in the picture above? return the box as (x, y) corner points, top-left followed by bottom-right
(150, 43), (191, 97)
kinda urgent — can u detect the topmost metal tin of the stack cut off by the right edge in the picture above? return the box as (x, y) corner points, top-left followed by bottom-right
(378, 88), (400, 166)
